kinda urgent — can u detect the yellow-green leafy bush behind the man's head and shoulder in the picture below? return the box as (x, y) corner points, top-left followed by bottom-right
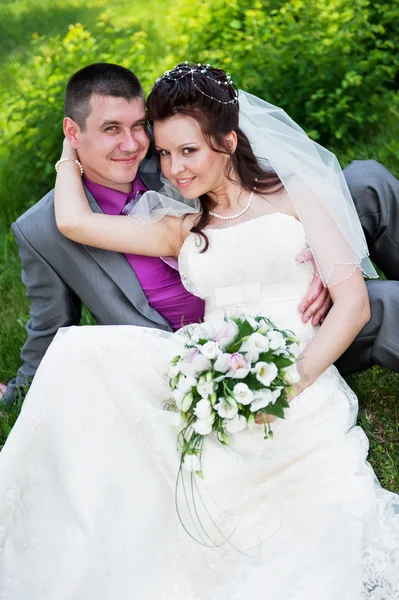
(0, 20), (164, 222)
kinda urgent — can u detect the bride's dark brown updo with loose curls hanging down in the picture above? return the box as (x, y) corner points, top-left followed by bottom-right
(147, 62), (282, 251)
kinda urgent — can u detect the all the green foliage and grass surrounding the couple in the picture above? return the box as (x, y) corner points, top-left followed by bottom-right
(0, 0), (399, 489)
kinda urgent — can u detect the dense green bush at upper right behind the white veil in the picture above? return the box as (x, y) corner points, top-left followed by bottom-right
(169, 0), (399, 146)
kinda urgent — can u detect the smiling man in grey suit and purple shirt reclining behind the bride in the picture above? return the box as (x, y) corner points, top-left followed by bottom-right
(0, 63), (399, 403)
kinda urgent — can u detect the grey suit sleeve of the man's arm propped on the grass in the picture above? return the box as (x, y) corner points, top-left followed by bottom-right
(5, 223), (82, 402)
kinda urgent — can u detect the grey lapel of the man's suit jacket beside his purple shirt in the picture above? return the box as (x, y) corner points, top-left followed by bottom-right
(83, 187), (170, 329)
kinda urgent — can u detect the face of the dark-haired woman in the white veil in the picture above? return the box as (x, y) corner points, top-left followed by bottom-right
(154, 115), (234, 199)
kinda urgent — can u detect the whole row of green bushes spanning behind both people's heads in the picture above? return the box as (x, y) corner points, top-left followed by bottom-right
(0, 0), (399, 223)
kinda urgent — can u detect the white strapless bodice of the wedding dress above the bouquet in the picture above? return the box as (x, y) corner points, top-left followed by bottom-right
(179, 213), (315, 339)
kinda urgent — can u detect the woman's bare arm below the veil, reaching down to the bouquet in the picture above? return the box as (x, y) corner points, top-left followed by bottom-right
(293, 268), (370, 394)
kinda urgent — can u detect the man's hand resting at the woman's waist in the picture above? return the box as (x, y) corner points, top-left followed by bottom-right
(296, 250), (332, 327)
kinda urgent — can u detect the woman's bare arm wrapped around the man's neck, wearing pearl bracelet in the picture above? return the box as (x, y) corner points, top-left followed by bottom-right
(54, 142), (188, 256)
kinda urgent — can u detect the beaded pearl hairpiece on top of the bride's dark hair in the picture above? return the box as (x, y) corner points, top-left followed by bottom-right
(154, 60), (238, 104)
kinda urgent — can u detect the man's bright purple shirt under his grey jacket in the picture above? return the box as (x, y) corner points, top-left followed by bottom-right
(84, 176), (204, 330)
